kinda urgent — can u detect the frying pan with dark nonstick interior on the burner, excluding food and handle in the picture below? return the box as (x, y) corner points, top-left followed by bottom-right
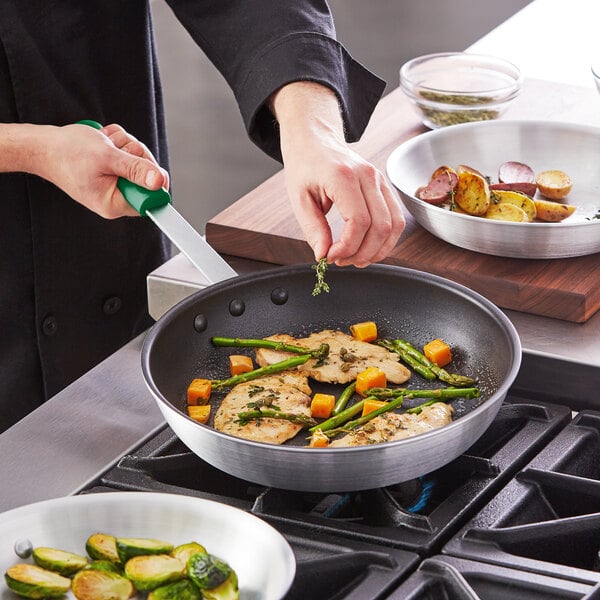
(142, 251), (521, 492)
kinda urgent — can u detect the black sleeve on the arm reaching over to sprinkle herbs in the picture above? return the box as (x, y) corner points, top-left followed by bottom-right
(162, 0), (385, 160)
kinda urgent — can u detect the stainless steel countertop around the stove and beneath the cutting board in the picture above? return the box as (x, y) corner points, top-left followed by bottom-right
(0, 0), (600, 511)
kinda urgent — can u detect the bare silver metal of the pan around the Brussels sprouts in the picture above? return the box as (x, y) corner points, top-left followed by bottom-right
(0, 492), (296, 600)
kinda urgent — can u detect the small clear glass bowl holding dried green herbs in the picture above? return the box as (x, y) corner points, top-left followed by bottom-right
(400, 52), (523, 129)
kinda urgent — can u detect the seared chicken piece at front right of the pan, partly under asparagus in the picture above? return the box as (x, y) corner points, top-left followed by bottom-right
(329, 402), (454, 448)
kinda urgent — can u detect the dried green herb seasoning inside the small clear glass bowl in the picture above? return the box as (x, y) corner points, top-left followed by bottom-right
(417, 92), (500, 127)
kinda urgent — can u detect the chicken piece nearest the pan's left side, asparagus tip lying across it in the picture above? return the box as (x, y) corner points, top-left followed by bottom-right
(214, 371), (311, 444)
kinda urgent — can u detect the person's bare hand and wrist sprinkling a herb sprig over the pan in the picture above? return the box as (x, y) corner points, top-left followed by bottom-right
(272, 82), (405, 267)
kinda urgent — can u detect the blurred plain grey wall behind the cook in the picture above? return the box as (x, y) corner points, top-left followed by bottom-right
(152, 0), (530, 232)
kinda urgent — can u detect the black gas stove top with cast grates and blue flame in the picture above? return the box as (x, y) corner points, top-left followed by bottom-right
(83, 396), (600, 600)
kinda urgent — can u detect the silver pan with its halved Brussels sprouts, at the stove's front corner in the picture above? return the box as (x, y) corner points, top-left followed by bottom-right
(0, 492), (296, 600)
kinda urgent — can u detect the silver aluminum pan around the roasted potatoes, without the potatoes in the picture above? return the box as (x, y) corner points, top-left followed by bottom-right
(387, 120), (600, 259)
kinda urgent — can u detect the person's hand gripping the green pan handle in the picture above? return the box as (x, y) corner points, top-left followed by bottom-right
(36, 124), (169, 219)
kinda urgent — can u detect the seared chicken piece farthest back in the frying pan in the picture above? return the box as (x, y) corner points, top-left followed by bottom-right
(256, 329), (410, 383)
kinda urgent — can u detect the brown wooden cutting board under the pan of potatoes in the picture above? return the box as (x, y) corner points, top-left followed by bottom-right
(206, 80), (600, 323)
